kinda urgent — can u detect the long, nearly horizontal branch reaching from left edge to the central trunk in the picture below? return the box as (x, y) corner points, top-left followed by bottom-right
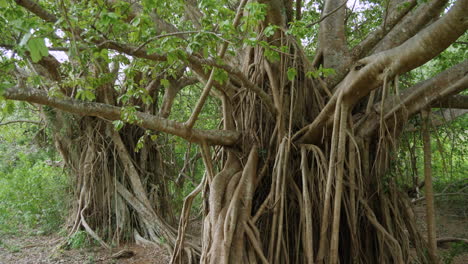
(3, 88), (239, 145)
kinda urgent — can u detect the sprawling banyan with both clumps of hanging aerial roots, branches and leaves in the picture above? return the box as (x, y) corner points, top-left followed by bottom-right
(0, 0), (468, 264)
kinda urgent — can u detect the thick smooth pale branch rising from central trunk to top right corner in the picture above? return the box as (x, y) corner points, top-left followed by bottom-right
(300, 0), (468, 143)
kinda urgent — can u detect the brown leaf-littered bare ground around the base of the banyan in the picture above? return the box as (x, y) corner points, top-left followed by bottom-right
(0, 202), (468, 264)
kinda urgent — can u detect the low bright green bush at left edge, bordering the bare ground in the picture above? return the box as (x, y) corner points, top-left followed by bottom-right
(0, 152), (68, 233)
